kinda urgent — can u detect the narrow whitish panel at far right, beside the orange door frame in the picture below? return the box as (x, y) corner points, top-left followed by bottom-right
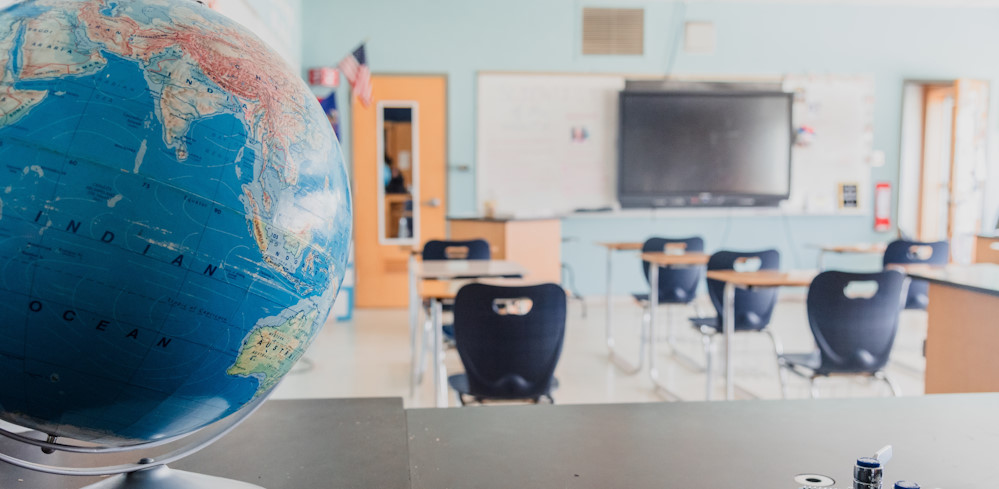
(947, 79), (989, 264)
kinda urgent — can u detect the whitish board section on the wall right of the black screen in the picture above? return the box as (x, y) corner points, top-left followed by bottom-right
(784, 75), (874, 215)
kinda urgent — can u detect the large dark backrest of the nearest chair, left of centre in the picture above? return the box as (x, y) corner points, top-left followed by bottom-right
(454, 283), (566, 399)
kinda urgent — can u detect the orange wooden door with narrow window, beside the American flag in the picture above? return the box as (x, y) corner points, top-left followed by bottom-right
(351, 75), (447, 307)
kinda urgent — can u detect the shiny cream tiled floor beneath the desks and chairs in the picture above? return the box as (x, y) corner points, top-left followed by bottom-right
(274, 291), (926, 407)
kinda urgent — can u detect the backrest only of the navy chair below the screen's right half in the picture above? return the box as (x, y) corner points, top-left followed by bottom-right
(708, 250), (780, 331)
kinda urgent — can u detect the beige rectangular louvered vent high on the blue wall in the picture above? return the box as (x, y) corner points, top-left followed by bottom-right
(583, 7), (645, 55)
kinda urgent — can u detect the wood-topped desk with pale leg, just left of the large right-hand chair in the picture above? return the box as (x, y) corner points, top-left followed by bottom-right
(707, 270), (817, 400)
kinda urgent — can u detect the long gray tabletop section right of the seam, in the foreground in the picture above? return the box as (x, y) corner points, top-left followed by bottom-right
(407, 394), (999, 489)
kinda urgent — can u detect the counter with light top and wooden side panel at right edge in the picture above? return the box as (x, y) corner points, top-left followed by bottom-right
(906, 263), (999, 394)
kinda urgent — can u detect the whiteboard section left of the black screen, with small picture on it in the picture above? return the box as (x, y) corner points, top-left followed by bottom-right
(476, 73), (624, 216)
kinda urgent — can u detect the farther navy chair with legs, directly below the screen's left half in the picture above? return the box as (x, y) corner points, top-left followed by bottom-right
(632, 236), (704, 342)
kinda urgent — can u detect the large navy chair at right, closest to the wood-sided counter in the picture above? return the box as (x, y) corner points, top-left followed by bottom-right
(779, 270), (906, 397)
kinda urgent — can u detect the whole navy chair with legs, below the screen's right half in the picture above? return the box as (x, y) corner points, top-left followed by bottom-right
(690, 250), (784, 393)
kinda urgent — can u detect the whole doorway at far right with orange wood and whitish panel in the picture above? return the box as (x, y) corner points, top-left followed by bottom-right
(898, 79), (989, 264)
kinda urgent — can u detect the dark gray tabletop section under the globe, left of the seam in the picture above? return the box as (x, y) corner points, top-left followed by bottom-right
(0, 399), (410, 489)
